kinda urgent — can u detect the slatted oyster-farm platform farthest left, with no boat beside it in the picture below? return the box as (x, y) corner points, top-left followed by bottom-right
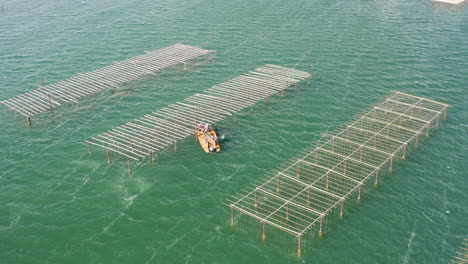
(0, 44), (213, 125)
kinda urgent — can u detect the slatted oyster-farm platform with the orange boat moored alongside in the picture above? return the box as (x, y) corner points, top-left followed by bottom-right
(85, 64), (310, 163)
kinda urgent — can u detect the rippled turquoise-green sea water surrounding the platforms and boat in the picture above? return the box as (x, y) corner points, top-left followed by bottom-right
(0, 0), (468, 263)
